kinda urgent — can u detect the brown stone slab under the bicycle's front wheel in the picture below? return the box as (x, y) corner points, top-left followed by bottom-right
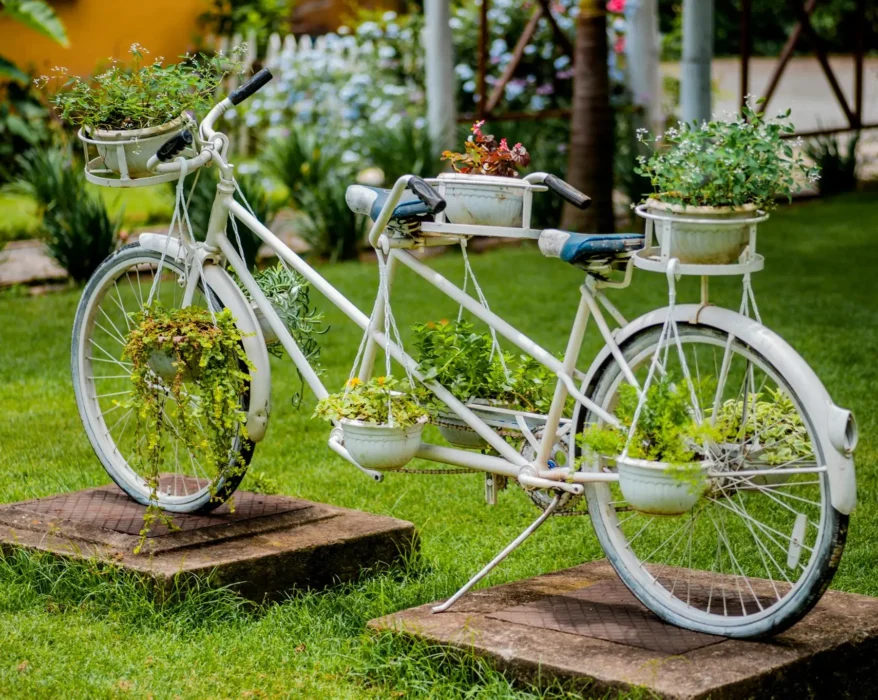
(0, 485), (416, 600)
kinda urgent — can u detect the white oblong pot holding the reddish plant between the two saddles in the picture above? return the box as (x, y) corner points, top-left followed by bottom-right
(439, 173), (530, 227)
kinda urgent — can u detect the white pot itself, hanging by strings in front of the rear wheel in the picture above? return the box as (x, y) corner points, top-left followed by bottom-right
(616, 457), (711, 515)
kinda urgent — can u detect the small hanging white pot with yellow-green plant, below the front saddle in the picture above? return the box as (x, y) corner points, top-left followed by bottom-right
(314, 376), (429, 471)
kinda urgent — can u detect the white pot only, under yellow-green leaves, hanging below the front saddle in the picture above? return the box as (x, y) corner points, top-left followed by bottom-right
(340, 416), (427, 471)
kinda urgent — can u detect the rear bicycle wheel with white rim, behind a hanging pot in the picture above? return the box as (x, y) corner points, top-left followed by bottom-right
(575, 323), (848, 637)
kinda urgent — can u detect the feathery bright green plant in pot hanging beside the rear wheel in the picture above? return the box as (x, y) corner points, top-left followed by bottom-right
(580, 374), (721, 465)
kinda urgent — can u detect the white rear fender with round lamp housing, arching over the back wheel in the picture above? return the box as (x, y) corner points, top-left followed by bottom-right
(582, 304), (857, 515)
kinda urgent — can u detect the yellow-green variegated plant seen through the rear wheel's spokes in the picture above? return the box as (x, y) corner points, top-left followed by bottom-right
(715, 389), (814, 465)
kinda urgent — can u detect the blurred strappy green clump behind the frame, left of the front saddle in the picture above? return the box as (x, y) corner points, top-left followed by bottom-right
(264, 126), (366, 261)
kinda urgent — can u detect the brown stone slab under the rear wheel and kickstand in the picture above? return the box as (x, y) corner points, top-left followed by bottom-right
(369, 560), (878, 700)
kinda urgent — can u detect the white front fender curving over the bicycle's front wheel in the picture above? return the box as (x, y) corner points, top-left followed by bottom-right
(138, 233), (271, 442)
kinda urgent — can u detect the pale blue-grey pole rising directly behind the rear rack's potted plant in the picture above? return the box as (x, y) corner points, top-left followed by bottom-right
(680, 0), (713, 122)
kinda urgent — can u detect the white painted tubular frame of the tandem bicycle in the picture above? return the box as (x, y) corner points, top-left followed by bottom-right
(187, 163), (637, 494)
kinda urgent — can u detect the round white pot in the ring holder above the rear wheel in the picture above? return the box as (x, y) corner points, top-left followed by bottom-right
(646, 199), (757, 265)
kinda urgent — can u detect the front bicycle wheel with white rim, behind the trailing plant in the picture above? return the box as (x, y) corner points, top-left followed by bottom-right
(71, 243), (254, 513)
